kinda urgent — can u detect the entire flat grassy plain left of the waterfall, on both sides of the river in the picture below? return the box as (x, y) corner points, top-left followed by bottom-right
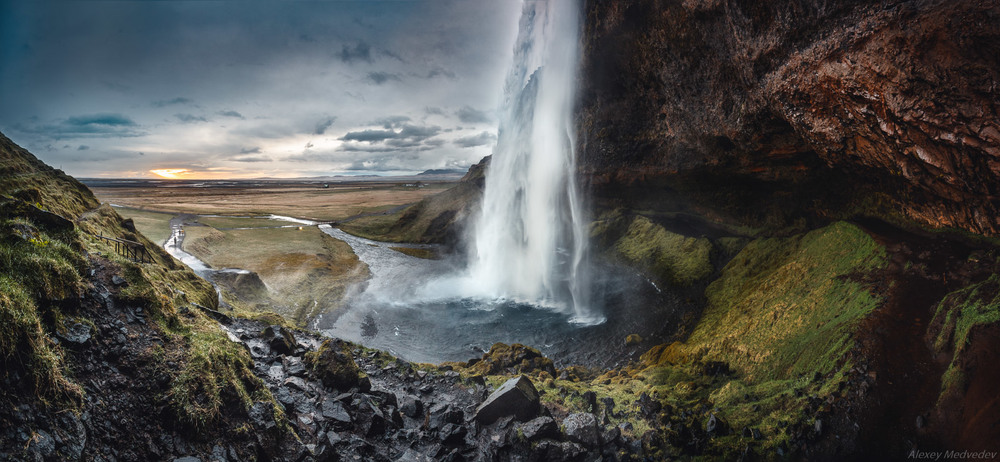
(93, 182), (451, 325)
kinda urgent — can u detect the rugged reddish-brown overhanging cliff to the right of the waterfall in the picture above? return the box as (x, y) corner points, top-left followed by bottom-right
(579, 0), (1000, 235)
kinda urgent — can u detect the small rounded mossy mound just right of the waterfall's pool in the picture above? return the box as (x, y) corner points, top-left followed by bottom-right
(614, 216), (713, 286)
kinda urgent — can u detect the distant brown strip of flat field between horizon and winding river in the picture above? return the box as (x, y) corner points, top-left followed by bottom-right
(93, 183), (453, 221)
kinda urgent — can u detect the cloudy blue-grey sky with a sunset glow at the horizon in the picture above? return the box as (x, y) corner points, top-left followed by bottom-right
(0, 0), (520, 178)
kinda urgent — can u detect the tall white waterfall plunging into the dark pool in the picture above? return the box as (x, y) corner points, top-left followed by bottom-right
(469, 0), (604, 323)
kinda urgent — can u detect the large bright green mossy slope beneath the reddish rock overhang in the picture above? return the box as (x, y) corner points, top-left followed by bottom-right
(686, 222), (887, 379)
